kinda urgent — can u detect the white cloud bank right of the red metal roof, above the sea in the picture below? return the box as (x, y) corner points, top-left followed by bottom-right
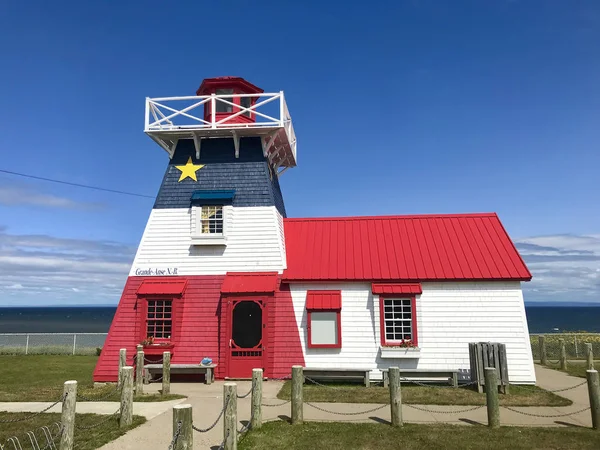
(516, 234), (600, 302)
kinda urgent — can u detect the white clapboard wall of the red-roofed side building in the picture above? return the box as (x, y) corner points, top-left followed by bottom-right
(290, 281), (535, 383)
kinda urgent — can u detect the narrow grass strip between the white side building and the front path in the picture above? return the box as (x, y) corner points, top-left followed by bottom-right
(277, 381), (573, 406)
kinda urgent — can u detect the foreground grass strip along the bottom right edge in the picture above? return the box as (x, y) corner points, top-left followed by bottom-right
(238, 421), (600, 450)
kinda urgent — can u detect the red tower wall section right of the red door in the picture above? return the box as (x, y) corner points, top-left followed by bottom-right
(265, 284), (304, 378)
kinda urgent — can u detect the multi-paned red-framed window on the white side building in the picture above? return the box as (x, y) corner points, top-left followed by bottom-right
(379, 297), (417, 346)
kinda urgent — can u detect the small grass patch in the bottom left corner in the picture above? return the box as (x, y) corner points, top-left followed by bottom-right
(0, 412), (146, 450)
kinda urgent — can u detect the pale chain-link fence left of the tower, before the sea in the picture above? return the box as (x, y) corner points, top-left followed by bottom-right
(0, 333), (107, 355)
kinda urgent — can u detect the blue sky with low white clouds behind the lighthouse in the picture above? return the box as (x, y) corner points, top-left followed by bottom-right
(0, 0), (600, 305)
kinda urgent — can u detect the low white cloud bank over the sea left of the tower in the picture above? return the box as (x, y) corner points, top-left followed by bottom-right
(0, 227), (135, 306)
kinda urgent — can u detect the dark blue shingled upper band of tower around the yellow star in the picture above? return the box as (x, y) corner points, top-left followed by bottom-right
(154, 138), (286, 217)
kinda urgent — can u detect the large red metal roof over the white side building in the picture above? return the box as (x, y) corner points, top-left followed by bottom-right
(283, 213), (531, 281)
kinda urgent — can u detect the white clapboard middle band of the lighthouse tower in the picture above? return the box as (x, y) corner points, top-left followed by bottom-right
(130, 206), (285, 276)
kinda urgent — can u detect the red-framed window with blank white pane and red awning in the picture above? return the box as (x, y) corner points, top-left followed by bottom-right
(306, 291), (342, 348)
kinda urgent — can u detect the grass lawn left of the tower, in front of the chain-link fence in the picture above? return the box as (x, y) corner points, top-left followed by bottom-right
(0, 355), (184, 402)
